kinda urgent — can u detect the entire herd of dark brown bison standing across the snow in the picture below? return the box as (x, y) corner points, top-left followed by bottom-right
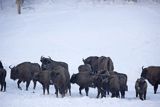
(0, 56), (160, 100)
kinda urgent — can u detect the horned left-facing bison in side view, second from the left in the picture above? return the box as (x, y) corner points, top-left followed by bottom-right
(9, 62), (41, 90)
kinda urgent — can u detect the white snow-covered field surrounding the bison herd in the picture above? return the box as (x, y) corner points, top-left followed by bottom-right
(0, 0), (160, 107)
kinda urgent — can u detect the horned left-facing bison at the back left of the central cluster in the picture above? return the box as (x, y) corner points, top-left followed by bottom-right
(83, 56), (99, 74)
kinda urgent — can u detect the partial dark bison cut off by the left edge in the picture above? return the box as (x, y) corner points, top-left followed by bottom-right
(0, 68), (7, 91)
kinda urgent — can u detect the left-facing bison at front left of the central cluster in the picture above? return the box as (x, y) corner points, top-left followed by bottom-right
(70, 72), (94, 96)
